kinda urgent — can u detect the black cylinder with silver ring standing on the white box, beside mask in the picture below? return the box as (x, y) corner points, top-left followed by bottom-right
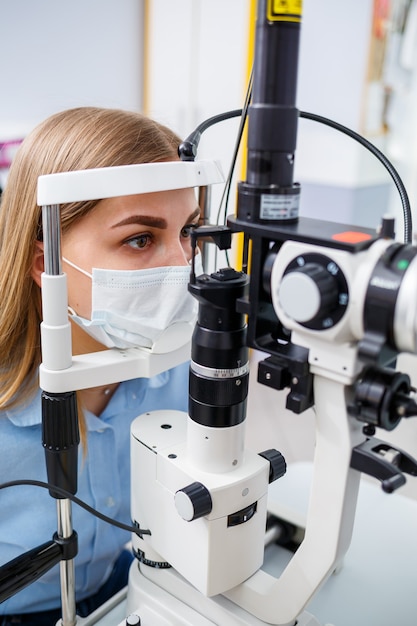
(189, 268), (249, 428)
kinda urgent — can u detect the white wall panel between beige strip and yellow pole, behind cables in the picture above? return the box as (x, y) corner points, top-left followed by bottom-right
(145, 0), (250, 265)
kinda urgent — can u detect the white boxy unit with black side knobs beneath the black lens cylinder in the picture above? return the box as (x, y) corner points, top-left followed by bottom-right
(128, 411), (269, 596)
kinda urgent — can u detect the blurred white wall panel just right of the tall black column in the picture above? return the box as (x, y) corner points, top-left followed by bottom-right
(295, 0), (375, 186)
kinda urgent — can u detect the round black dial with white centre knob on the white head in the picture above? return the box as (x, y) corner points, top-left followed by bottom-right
(278, 253), (349, 330)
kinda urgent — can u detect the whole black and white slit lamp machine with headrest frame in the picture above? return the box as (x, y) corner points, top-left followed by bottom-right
(0, 0), (417, 626)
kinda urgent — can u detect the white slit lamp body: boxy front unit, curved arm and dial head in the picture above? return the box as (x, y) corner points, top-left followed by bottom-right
(128, 225), (417, 626)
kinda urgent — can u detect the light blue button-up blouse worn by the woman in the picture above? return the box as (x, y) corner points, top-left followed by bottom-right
(0, 363), (188, 615)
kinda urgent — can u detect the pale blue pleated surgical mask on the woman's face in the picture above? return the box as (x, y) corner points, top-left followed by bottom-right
(64, 254), (202, 353)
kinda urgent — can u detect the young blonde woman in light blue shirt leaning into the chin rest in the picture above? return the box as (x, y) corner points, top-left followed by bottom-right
(0, 107), (203, 626)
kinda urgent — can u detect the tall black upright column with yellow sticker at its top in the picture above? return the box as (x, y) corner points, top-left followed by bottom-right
(238, 0), (301, 222)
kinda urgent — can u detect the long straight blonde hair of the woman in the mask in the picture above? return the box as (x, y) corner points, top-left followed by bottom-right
(0, 107), (180, 438)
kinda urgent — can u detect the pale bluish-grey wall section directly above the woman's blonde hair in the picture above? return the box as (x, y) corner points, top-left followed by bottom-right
(0, 0), (143, 141)
